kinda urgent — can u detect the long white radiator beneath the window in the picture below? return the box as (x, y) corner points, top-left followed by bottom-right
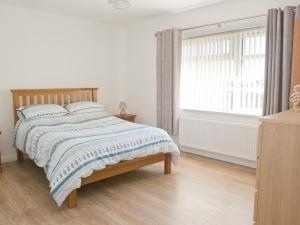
(179, 110), (259, 167)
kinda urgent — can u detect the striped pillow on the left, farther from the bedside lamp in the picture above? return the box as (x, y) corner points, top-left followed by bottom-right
(17, 104), (68, 120)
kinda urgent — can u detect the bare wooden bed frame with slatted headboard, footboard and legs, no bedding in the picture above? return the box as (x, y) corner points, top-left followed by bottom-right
(11, 88), (171, 208)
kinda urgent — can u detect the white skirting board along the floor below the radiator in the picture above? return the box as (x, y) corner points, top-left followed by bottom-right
(180, 146), (256, 169)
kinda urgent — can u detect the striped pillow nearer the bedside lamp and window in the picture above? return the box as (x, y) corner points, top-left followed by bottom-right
(65, 101), (106, 113)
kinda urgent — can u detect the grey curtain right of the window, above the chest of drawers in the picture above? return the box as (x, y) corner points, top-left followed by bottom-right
(263, 7), (295, 116)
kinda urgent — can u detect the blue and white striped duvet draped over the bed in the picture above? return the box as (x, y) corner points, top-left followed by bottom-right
(15, 112), (179, 206)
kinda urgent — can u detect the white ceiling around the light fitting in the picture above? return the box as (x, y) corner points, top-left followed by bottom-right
(0, 0), (227, 25)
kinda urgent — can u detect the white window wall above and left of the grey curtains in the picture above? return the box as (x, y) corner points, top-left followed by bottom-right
(125, 0), (299, 125)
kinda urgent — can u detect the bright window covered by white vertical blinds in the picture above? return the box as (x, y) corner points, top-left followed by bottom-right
(180, 28), (265, 115)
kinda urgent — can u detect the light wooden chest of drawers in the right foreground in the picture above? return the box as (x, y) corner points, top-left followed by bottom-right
(254, 111), (300, 225)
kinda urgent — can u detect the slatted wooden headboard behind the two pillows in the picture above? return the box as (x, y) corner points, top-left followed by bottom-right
(11, 88), (98, 123)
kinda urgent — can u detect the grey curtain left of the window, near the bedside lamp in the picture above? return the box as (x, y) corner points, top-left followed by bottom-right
(155, 29), (181, 135)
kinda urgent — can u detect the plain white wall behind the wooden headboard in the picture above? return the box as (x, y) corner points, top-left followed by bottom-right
(0, 4), (125, 161)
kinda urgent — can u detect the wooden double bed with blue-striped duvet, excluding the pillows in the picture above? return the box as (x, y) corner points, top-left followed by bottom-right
(11, 88), (179, 208)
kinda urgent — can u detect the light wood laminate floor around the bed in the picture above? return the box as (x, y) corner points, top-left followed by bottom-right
(0, 154), (255, 225)
